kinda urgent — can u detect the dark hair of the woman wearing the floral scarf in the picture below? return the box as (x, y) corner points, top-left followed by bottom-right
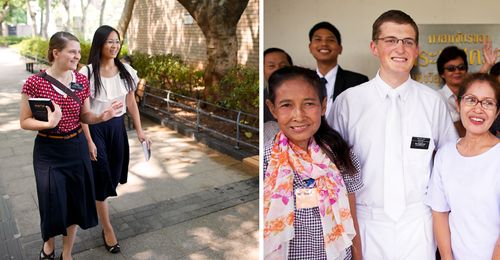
(269, 66), (356, 174)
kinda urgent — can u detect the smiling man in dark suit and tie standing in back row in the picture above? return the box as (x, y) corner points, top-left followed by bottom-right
(309, 22), (368, 124)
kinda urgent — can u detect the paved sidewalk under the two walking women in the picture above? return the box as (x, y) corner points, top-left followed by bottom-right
(0, 48), (259, 259)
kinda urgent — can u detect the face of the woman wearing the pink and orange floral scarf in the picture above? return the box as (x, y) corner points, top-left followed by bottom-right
(266, 78), (326, 150)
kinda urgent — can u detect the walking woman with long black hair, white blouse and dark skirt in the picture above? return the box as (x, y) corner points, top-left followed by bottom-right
(80, 25), (151, 254)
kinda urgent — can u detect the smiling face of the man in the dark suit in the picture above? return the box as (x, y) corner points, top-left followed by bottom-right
(309, 28), (342, 64)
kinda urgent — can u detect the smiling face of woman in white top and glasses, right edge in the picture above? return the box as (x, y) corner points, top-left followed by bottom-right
(459, 81), (499, 135)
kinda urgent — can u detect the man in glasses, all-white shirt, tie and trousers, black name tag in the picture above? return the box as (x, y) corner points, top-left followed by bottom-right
(332, 10), (458, 260)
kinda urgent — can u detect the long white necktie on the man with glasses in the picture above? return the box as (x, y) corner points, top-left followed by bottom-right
(384, 91), (406, 221)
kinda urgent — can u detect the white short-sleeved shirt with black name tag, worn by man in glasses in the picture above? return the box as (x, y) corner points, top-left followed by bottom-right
(328, 73), (458, 208)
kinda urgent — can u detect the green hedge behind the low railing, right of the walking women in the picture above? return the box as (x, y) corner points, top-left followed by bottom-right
(131, 52), (259, 114)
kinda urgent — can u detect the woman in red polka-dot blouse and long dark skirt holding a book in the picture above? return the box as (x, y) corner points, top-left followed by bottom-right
(19, 32), (123, 259)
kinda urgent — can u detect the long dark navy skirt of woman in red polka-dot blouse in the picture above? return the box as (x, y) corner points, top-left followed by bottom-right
(33, 133), (97, 241)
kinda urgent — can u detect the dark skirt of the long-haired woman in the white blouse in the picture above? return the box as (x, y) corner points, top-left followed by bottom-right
(89, 116), (130, 201)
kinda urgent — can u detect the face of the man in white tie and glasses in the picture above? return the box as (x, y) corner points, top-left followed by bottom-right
(370, 22), (418, 83)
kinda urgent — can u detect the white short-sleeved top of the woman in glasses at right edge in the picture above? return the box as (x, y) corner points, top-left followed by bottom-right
(425, 142), (500, 260)
